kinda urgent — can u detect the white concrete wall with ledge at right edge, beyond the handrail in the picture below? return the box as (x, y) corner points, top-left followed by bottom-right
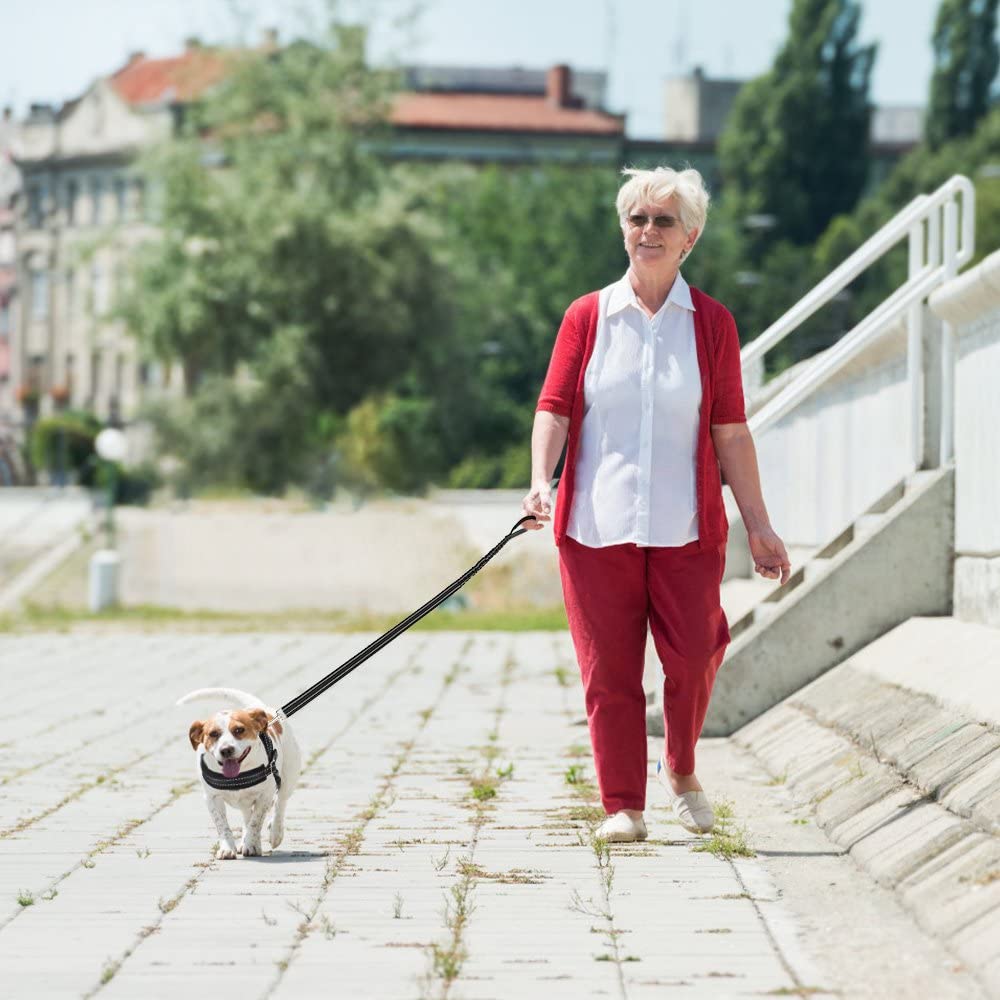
(930, 251), (1000, 626)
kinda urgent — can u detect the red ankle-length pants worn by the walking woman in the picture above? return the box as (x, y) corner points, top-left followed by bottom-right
(559, 537), (729, 814)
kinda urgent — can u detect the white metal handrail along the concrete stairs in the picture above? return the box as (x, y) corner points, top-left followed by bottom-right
(740, 174), (975, 468)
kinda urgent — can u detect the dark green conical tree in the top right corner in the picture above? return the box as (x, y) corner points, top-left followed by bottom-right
(925, 0), (1000, 149)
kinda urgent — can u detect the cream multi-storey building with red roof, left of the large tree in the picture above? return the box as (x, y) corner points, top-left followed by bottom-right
(10, 41), (224, 432)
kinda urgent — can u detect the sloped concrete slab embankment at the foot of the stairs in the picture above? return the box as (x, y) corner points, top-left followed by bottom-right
(733, 662), (1000, 995)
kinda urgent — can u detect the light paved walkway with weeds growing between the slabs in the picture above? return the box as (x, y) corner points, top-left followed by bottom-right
(0, 633), (978, 1000)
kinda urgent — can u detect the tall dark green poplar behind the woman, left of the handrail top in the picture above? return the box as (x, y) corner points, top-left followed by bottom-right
(719, 0), (876, 245)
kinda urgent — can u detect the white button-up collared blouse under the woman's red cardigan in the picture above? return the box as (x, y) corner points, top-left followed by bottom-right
(566, 273), (701, 548)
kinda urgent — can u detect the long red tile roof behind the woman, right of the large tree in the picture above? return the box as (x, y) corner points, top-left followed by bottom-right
(391, 93), (625, 135)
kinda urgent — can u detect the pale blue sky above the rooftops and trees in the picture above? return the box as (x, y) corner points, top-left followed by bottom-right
(0, 0), (939, 138)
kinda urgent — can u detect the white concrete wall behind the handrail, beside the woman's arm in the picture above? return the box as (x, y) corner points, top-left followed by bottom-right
(753, 327), (915, 546)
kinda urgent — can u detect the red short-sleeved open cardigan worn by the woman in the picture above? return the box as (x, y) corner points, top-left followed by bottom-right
(536, 288), (746, 547)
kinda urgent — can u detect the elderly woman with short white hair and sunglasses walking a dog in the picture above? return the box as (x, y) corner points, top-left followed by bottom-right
(523, 167), (790, 841)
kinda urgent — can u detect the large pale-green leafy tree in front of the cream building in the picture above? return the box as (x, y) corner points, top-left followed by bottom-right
(121, 20), (472, 492)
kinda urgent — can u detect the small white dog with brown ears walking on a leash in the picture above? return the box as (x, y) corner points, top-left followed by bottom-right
(177, 688), (302, 860)
